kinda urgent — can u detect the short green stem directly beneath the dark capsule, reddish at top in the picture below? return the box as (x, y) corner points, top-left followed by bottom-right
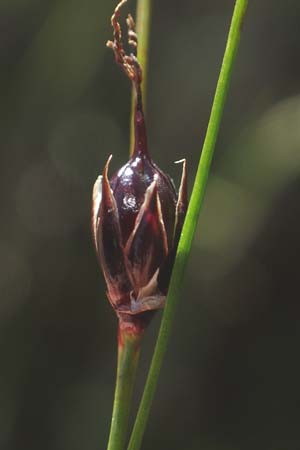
(107, 329), (141, 450)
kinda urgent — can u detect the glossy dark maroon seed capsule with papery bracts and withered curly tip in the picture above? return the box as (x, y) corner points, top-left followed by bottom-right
(92, 0), (187, 330)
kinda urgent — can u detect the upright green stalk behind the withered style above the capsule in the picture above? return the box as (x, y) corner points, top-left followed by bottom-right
(130, 0), (152, 155)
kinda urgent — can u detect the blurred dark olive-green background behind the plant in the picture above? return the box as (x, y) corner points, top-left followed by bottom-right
(0, 0), (300, 450)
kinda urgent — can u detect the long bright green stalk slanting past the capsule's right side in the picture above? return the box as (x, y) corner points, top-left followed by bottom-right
(128, 0), (247, 450)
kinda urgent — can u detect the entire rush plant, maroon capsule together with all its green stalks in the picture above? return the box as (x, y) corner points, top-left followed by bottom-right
(92, 0), (247, 450)
